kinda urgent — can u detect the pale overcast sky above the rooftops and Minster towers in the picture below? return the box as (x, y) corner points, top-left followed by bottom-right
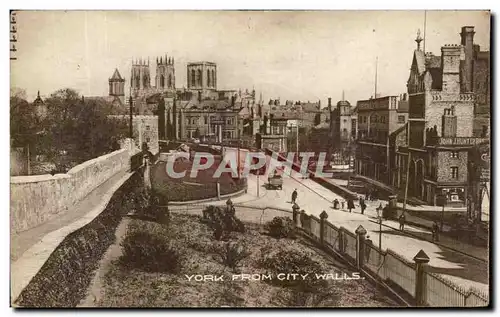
(11, 11), (490, 106)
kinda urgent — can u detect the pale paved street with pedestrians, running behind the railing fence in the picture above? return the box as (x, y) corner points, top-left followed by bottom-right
(187, 149), (488, 293)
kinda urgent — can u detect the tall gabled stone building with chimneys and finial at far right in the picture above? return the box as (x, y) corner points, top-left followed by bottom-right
(396, 26), (489, 205)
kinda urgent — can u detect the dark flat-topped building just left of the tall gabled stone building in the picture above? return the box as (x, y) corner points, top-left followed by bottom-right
(355, 95), (408, 184)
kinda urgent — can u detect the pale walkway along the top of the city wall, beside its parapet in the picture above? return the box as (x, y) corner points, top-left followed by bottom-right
(10, 170), (133, 302)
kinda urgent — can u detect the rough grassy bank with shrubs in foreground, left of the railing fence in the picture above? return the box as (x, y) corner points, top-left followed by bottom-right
(96, 214), (397, 307)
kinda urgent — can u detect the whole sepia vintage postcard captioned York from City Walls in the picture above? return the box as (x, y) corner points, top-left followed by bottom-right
(10, 10), (491, 308)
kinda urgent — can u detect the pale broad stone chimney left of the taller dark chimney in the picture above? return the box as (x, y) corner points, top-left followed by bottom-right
(441, 44), (463, 93)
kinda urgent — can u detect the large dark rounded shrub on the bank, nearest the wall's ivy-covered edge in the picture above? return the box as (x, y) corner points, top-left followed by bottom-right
(121, 229), (182, 272)
